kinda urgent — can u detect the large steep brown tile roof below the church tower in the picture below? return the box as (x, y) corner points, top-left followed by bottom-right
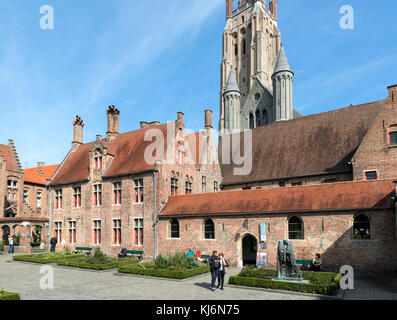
(219, 100), (386, 185)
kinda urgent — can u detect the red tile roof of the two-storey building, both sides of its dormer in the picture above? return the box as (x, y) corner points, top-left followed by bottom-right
(51, 123), (172, 185)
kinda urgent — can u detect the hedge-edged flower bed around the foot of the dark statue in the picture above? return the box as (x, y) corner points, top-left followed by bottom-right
(229, 267), (342, 295)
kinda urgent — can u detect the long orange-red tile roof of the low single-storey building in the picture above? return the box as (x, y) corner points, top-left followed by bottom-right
(160, 180), (395, 216)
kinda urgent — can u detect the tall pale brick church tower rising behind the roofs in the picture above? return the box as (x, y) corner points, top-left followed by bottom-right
(219, 0), (281, 130)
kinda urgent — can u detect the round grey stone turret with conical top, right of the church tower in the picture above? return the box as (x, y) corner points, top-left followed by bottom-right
(272, 45), (294, 122)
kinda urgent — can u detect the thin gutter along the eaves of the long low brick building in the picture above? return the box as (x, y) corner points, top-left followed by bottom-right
(158, 206), (394, 219)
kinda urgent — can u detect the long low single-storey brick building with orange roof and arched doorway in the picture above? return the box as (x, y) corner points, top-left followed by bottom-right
(159, 180), (397, 272)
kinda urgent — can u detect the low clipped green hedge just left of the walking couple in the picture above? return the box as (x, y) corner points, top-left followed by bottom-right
(119, 265), (210, 279)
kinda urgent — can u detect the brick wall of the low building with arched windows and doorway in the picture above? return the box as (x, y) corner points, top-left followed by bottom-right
(159, 210), (397, 272)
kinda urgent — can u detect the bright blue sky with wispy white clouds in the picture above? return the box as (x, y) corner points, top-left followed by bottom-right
(0, 0), (397, 167)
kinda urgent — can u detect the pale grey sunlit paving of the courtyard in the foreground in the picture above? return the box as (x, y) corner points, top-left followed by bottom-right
(0, 254), (320, 300)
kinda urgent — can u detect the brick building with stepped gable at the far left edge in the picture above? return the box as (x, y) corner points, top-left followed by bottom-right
(0, 140), (57, 252)
